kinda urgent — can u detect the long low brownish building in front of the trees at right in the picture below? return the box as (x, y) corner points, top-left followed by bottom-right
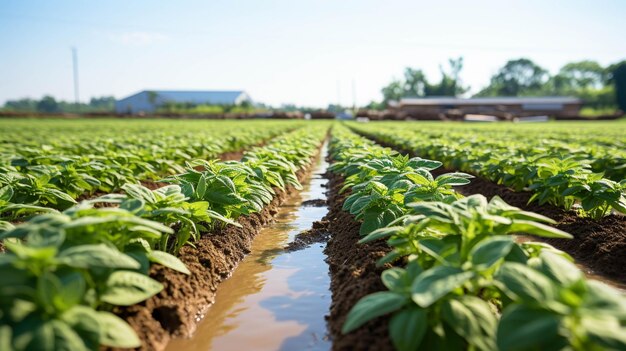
(391, 96), (582, 119)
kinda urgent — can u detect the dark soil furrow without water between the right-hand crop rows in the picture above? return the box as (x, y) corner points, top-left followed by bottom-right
(364, 135), (626, 283)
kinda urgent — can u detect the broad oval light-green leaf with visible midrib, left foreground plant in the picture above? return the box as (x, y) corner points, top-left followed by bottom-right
(100, 271), (163, 306)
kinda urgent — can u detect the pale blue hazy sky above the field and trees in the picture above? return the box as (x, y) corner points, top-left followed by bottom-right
(0, 0), (626, 106)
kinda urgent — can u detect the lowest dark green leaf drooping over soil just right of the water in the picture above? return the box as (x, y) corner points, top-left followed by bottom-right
(341, 291), (408, 334)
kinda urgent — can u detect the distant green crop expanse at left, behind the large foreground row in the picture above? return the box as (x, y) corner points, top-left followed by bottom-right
(0, 120), (299, 219)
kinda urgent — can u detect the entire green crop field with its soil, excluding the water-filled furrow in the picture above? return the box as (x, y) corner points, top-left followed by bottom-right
(0, 119), (626, 350)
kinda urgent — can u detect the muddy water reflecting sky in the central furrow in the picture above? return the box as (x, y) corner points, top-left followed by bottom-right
(167, 145), (331, 351)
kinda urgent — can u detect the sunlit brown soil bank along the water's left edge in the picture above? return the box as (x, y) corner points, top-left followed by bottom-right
(115, 146), (324, 350)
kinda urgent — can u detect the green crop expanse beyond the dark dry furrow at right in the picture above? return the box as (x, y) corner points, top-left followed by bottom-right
(351, 123), (626, 219)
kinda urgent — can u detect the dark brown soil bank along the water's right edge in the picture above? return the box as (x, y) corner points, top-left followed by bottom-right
(324, 174), (393, 351)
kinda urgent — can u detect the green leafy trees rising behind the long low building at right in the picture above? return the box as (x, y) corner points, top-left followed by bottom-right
(368, 57), (626, 111)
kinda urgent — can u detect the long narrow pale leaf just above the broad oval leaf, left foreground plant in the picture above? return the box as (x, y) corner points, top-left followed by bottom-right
(58, 244), (141, 269)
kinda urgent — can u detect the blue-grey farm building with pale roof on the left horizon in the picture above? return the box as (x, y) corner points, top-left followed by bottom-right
(115, 90), (252, 114)
